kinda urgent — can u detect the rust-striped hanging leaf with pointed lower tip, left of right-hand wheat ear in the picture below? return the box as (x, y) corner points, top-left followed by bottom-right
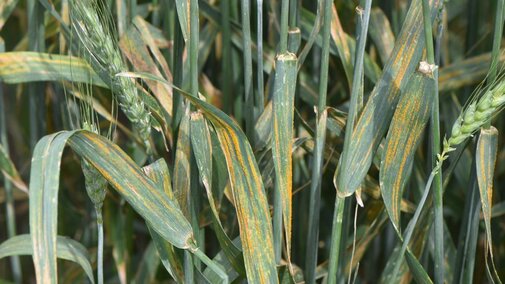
(380, 71), (435, 232)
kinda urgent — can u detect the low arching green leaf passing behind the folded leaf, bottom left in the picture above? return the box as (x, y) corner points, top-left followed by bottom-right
(0, 234), (95, 283)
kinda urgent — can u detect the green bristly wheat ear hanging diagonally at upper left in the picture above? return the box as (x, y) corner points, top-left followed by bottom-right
(70, 0), (151, 153)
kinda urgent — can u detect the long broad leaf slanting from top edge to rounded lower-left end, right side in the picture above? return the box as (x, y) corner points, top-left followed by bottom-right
(334, 0), (440, 197)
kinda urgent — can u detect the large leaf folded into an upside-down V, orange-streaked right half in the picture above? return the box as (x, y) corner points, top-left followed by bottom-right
(30, 131), (195, 283)
